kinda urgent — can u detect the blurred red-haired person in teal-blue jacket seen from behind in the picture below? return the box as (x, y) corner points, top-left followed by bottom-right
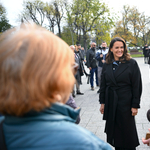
(0, 24), (111, 150)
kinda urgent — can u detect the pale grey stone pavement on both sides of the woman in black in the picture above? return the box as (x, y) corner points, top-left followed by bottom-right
(75, 57), (150, 150)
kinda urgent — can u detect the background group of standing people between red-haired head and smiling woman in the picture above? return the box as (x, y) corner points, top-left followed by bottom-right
(70, 42), (108, 97)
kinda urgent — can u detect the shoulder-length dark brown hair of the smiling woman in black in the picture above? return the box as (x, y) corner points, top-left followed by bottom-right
(106, 37), (131, 64)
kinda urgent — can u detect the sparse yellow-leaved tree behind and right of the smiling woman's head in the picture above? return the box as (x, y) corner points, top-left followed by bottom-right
(114, 5), (150, 45)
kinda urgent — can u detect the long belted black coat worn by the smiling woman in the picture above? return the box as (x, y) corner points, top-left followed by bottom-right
(99, 59), (142, 148)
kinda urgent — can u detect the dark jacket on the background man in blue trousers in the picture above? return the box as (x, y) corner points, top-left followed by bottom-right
(86, 49), (97, 68)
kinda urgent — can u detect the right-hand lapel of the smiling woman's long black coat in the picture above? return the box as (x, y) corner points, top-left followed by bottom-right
(114, 62), (129, 78)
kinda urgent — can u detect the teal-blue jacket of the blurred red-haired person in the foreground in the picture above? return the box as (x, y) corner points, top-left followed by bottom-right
(3, 103), (111, 150)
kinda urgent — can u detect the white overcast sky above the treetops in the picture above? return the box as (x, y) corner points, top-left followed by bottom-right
(0, 0), (150, 26)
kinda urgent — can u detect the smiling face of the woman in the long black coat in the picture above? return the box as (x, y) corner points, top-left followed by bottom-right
(110, 41), (124, 61)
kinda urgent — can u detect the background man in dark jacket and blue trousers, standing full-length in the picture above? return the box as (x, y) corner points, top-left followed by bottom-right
(86, 42), (99, 90)
